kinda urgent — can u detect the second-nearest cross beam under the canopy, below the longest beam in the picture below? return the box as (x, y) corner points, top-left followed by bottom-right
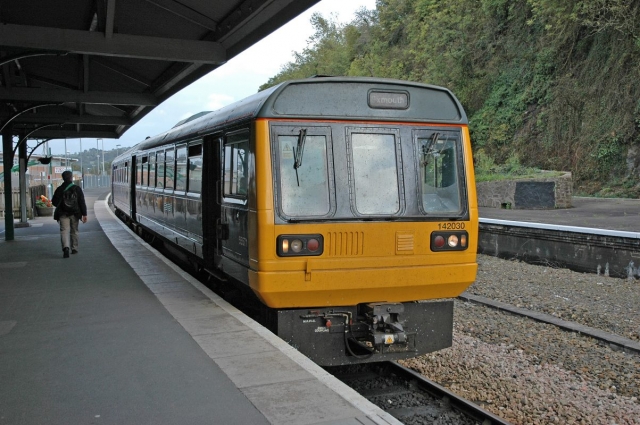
(0, 87), (159, 106)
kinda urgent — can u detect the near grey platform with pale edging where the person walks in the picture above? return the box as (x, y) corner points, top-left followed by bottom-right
(0, 188), (400, 425)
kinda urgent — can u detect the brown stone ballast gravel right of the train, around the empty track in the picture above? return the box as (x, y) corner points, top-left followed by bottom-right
(401, 255), (640, 425)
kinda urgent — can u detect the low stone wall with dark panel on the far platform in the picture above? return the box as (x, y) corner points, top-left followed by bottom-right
(476, 173), (573, 209)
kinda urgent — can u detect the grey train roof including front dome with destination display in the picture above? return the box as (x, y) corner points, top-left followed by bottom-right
(124, 77), (468, 155)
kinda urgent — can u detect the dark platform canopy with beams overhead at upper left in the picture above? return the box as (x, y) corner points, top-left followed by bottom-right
(0, 0), (319, 139)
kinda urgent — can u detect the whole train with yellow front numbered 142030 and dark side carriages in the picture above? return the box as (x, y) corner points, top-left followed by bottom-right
(112, 77), (478, 365)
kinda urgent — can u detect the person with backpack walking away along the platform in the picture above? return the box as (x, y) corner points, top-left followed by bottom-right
(51, 171), (87, 258)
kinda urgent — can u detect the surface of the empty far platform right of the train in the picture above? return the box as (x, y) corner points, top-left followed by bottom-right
(479, 197), (640, 232)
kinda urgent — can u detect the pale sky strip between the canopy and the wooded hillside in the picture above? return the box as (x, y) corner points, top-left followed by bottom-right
(48, 0), (376, 155)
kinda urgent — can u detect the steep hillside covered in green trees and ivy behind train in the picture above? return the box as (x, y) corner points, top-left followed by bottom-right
(262, 0), (640, 197)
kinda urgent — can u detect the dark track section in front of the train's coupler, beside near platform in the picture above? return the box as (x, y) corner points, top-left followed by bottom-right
(325, 362), (510, 425)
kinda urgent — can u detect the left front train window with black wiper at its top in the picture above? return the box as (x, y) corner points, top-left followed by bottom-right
(276, 128), (331, 217)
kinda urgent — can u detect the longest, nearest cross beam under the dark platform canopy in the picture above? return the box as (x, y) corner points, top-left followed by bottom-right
(0, 24), (226, 65)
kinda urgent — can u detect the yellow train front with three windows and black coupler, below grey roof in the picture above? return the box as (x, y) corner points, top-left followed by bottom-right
(249, 115), (478, 365)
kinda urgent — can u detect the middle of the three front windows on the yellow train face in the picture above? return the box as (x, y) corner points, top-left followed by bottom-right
(349, 129), (400, 215)
